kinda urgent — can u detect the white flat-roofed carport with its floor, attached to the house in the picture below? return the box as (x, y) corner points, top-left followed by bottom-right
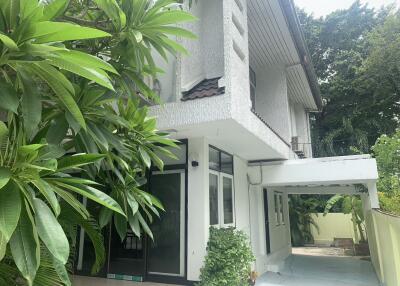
(249, 155), (379, 286)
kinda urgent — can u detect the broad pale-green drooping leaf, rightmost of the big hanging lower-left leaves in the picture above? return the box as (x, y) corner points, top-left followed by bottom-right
(33, 199), (69, 264)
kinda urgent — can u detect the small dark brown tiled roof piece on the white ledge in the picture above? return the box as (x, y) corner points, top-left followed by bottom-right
(181, 77), (225, 101)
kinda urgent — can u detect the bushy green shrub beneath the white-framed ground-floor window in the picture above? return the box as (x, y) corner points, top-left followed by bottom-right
(198, 227), (255, 286)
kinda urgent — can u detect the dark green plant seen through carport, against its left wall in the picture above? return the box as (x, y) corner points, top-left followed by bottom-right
(289, 195), (320, 246)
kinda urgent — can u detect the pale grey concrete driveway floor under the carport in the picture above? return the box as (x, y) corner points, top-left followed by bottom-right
(256, 255), (380, 286)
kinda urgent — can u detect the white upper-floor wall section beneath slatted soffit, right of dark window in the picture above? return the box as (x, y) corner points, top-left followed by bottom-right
(254, 66), (291, 142)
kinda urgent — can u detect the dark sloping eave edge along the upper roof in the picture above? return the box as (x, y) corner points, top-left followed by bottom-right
(278, 0), (323, 111)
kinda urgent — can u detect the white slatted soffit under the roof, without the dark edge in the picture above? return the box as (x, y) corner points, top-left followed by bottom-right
(247, 0), (317, 110)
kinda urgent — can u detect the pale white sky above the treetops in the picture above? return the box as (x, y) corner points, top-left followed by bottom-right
(294, 0), (400, 17)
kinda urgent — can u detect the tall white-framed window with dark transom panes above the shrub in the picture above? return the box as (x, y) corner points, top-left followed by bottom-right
(209, 146), (235, 227)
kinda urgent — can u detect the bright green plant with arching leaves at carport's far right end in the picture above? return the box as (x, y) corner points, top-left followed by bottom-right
(324, 194), (366, 242)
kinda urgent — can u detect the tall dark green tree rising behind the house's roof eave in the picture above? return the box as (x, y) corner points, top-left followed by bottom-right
(300, 1), (397, 156)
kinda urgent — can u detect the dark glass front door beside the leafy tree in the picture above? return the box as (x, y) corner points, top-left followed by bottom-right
(147, 170), (185, 277)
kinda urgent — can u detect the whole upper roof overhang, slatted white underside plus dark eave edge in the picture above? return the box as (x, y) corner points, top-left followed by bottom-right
(248, 0), (323, 111)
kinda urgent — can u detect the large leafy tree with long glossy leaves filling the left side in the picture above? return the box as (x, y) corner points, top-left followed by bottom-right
(0, 0), (195, 285)
